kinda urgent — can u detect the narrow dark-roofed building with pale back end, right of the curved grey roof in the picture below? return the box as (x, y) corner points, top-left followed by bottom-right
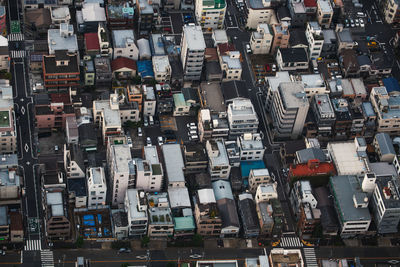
(238, 193), (260, 238)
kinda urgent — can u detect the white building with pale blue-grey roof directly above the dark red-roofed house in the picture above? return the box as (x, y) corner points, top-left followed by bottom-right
(112, 30), (139, 60)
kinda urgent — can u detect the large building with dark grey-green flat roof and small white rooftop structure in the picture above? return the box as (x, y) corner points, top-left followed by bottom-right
(329, 175), (371, 238)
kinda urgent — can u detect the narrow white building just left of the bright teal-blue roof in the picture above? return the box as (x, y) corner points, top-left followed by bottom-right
(206, 140), (231, 180)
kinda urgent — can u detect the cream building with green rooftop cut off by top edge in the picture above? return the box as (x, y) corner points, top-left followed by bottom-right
(196, 0), (226, 30)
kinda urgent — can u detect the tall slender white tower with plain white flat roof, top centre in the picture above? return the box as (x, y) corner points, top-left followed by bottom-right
(181, 24), (206, 81)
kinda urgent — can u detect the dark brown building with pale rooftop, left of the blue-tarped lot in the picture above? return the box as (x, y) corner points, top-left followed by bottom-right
(43, 190), (71, 240)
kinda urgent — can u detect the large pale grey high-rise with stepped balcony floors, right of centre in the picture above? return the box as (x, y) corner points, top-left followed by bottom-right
(271, 82), (309, 139)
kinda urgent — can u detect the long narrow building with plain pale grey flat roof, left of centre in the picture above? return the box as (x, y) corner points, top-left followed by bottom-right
(161, 144), (186, 188)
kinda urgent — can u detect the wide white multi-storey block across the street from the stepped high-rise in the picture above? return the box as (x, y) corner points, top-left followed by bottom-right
(227, 98), (258, 135)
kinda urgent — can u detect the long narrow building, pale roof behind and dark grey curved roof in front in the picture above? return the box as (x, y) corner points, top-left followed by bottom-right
(212, 180), (240, 238)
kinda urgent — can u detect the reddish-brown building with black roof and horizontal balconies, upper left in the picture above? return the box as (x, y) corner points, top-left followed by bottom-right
(42, 50), (80, 92)
